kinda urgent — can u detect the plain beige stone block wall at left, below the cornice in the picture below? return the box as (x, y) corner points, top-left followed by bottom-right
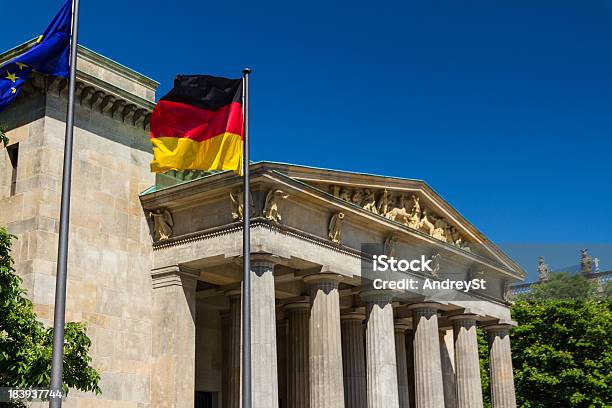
(0, 74), (154, 407)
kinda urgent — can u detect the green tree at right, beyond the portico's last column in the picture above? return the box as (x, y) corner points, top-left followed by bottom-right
(478, 273), (612, 408)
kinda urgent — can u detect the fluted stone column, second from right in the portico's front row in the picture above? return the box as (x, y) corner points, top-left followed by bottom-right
(450, 315), (483, 408)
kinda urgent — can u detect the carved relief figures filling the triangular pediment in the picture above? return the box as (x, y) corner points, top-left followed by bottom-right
(330, 185), (470, 251)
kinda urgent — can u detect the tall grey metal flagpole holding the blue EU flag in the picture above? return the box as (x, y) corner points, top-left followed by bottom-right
(49, 0), (79, 408)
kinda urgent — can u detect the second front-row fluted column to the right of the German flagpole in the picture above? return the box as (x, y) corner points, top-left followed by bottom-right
(304, 274), (344, 408)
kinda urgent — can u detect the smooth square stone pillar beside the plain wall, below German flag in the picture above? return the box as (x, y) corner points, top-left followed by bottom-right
(151, 265), (198, 408)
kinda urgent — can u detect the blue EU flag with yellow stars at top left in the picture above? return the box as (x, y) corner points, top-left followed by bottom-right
(0, 0), (72, 111)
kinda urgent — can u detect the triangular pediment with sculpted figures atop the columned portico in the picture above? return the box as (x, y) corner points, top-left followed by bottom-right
(264, 163), (524, 276)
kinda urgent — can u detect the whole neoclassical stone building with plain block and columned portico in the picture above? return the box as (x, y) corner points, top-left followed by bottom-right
(0, 44), (524, 408)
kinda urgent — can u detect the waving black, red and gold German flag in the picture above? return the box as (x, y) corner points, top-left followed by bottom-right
(151, 75), (244, 174)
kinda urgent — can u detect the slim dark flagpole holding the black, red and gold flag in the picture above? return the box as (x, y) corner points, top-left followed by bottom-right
(242, 68), (251, 408)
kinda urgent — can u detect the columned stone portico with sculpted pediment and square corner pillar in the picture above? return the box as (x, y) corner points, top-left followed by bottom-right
(141, 163), (524, 408)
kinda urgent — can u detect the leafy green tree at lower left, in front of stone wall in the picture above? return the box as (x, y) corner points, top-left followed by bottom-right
(0, 227), (101, 404)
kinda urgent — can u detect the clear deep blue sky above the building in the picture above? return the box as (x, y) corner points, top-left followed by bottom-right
(0, 0), (612, 278)
